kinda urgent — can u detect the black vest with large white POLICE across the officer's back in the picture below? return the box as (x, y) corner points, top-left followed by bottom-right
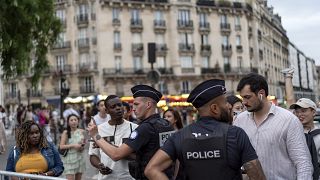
(180, 123), (241, 180)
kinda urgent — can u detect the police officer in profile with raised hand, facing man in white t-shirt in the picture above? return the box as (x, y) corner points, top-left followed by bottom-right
(88, 85), (174, 179)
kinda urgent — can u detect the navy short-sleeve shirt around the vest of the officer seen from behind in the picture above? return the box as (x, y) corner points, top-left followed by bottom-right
(161, 117), (258, 169)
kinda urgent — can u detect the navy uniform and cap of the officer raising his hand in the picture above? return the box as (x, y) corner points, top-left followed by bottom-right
(124, 85), (175, 179)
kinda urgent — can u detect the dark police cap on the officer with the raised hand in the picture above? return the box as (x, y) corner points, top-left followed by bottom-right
(131, 85), (162, 102)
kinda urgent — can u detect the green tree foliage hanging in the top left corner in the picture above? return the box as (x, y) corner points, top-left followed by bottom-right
(0, 0), (61, 85)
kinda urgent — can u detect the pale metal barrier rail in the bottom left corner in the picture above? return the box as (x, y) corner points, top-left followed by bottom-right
(0, 171), (66, 180)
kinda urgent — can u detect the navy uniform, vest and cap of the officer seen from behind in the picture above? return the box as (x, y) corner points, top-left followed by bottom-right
(161, 80), (258, 180)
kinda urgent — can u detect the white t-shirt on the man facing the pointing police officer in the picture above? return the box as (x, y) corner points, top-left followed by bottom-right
(88, 120), (138, 180)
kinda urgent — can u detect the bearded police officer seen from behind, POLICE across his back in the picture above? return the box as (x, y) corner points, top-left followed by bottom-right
(145, 79), (265, 180)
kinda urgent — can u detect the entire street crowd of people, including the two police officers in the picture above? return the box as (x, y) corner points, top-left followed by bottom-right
(0, 73), (320, 180)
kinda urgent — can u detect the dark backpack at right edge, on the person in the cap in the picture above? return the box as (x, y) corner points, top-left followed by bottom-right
(305, 129), (320, 180)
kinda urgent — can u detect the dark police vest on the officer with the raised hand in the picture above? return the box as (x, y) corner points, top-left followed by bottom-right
(136, 116), (175, 179)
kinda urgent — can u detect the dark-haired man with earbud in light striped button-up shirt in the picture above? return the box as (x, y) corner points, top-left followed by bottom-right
(234, 73), (313, 180)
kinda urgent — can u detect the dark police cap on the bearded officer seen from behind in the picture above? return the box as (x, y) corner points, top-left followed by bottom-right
(187, 79), (226, 108)
